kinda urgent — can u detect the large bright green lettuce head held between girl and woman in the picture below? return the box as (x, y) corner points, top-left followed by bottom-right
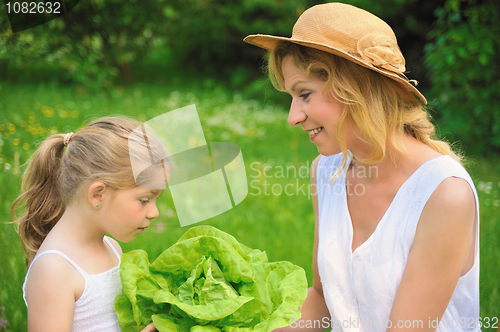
(115, 226), (307, 332)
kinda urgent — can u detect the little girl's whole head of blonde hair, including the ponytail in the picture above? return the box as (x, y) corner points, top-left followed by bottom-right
(11, 117), (170, 266)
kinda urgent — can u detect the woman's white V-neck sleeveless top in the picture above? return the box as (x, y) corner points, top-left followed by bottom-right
(317, 153), (481, 332)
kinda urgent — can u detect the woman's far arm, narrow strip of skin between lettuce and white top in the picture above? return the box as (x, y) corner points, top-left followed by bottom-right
(275, 156), (330, 332)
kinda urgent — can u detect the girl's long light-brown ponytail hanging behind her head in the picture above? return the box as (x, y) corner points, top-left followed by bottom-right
(10, 134), (64, 266)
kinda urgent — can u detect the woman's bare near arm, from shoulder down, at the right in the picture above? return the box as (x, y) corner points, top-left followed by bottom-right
(387, 177), (476, 332)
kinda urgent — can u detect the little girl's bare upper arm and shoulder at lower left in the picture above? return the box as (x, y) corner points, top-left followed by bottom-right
(26, 255), (84, 332)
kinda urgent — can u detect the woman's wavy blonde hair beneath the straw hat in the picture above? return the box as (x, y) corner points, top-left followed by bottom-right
(267, 41), (463, 182)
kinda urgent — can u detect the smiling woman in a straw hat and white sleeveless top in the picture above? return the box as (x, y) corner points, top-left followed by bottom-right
(245, 3), (481, 332)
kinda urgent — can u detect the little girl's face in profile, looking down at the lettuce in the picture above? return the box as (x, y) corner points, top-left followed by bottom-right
(101, 187), (163, 242)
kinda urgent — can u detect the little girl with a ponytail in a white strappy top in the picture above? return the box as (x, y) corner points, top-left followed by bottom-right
(12, 117), (168, 332)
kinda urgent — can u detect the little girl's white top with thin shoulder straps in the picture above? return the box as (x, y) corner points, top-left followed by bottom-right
(23, 237), (122, 332)
